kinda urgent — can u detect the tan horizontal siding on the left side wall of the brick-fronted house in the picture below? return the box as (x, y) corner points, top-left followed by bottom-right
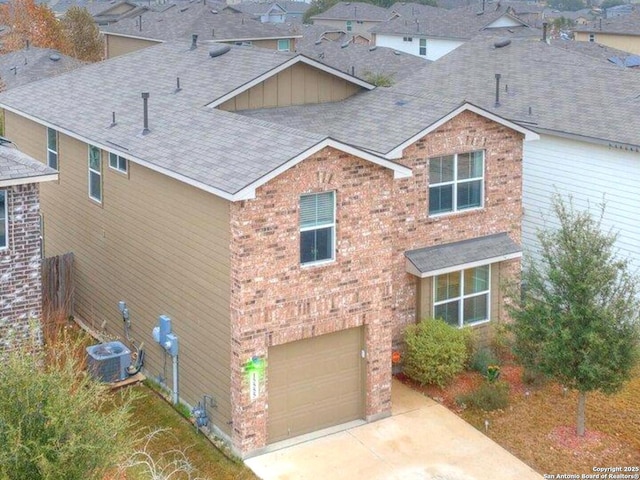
(6, 112), (231, 434)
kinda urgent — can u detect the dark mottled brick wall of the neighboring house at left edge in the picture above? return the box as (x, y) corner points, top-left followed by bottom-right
(0, 183), (42, 350)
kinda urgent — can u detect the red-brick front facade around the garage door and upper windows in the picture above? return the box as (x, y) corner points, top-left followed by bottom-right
(231, 112), (522, 453)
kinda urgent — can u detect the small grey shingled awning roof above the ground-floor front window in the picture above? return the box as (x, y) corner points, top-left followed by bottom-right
(404, 233), (522, 278)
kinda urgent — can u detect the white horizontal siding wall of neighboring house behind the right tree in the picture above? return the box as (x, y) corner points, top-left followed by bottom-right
(522, 134), (640, 270)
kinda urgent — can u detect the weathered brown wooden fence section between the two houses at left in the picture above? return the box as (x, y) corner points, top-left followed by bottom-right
(42, 253), (75, 318)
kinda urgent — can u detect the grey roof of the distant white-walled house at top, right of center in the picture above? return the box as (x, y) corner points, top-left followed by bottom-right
(370, 3), (531, 40)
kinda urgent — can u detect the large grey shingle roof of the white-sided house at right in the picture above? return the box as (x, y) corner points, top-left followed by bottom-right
(390, 38), (640, 150)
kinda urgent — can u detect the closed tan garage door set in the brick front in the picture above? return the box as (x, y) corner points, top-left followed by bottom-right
(267, 327), (365, 443)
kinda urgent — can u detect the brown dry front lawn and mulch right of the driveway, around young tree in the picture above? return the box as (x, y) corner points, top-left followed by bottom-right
(401, 366), (640, 475)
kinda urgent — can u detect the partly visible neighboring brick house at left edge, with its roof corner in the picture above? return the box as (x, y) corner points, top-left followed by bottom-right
(0, 138), (58, 351)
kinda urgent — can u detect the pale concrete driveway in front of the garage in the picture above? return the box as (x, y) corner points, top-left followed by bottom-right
(245, 380), (542, 480)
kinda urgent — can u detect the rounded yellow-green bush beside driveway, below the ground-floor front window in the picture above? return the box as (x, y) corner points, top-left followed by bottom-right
(404, 319), (471, 387)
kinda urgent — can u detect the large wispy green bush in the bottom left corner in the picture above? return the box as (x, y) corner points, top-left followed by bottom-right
(0, 330), (134, 480)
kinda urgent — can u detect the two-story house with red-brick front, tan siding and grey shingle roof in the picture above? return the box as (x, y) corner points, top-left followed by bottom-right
(0, 42), (537, 457)
